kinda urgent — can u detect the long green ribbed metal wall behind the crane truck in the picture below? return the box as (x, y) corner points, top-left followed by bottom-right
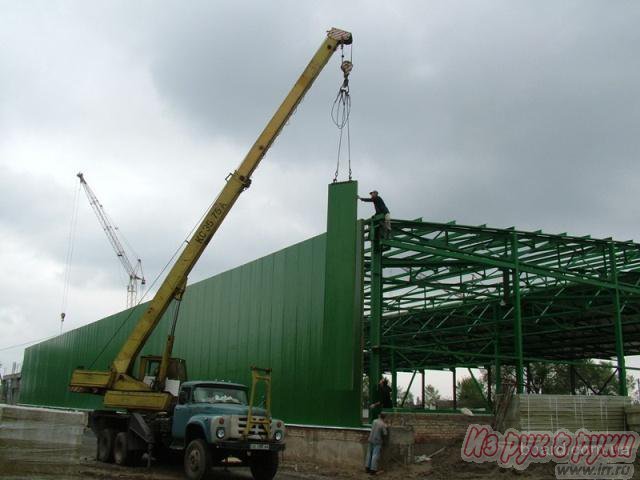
(21, 186), (361, 426)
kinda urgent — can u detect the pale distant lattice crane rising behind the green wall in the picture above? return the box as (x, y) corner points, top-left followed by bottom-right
(77, 172), (146, 308)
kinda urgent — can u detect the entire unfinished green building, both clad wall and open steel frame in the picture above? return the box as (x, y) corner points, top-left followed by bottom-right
(21, 188), (640, 427)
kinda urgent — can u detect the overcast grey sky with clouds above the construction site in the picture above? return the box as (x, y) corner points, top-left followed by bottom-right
(0, 0), (640, 398)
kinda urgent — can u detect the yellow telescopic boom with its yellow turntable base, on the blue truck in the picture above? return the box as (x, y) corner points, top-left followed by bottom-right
(70, 28), (352, 411)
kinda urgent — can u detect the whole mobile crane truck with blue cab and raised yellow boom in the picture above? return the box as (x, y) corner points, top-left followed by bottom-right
(69, 28), (352, 480)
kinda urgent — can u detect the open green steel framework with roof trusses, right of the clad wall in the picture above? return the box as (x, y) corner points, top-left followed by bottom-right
(362, 217), (640, 398)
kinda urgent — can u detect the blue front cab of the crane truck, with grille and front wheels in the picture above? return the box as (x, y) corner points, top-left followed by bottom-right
(171, 381), (286, 480)
